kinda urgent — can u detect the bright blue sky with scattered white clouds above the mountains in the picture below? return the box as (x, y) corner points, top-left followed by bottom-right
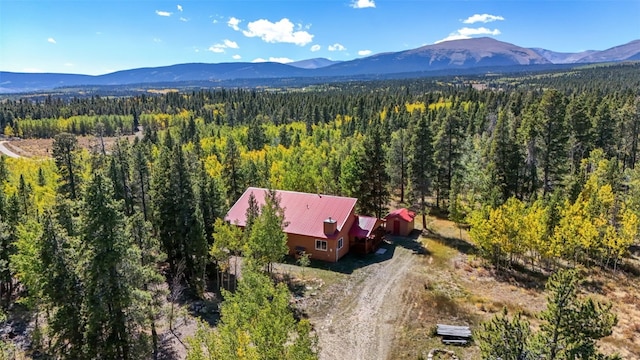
(0, 0), (640, 75)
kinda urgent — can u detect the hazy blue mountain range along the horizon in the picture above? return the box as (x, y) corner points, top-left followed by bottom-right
(0, 37), (640, 93)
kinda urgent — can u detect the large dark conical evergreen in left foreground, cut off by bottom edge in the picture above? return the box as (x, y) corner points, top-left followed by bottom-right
(81, 172), (156, 359)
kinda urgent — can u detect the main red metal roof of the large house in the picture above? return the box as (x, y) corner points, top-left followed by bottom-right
(224, 187), (358, 238)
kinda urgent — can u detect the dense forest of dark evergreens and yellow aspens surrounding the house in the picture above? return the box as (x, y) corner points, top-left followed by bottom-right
(0, 64), (640, 359)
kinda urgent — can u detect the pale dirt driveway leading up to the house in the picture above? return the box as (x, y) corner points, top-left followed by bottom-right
(308, 240), (417, 360)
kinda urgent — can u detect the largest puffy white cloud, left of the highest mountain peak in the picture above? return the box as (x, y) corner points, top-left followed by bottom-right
(242, 18), (313, 46)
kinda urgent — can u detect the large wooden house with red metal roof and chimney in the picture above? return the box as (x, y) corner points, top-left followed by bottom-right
(225, 187), (384, 262)
